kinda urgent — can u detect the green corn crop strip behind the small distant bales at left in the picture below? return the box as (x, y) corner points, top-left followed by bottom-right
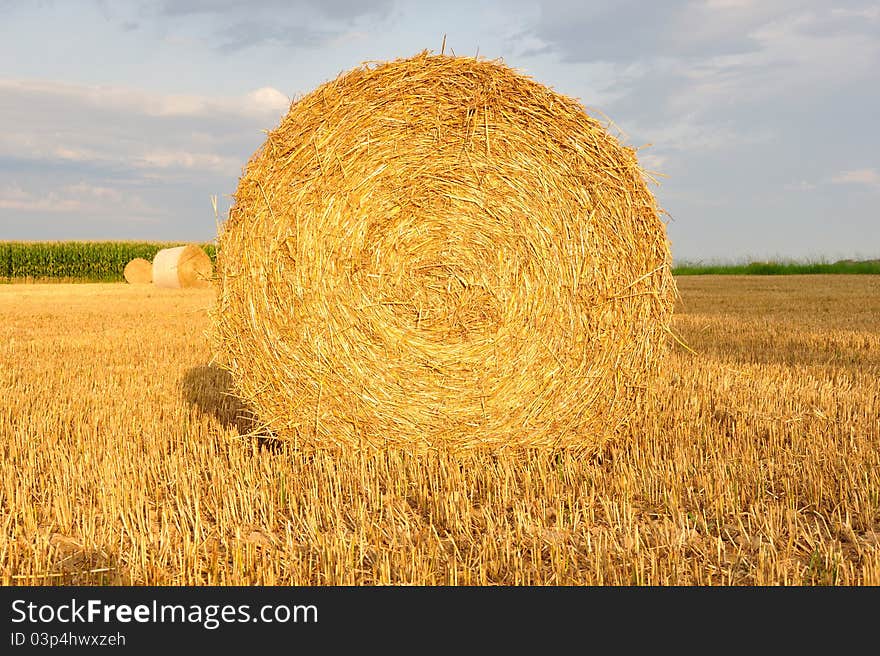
(0, 241), (215, 282)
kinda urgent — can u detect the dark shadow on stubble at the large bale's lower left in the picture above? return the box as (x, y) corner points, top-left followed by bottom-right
(181, 365), (278, 448)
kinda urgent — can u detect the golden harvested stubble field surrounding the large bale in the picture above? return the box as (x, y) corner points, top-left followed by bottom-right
(0, 276), (880, 585)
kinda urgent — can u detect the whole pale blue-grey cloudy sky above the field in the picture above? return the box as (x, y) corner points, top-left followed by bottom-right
(0, 0), (880, 261)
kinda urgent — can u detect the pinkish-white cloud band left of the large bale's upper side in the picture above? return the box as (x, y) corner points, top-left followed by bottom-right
(0, 79), (290, 178)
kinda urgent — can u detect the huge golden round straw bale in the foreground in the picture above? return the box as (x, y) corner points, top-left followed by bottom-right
(212, 53), (675, 449)
